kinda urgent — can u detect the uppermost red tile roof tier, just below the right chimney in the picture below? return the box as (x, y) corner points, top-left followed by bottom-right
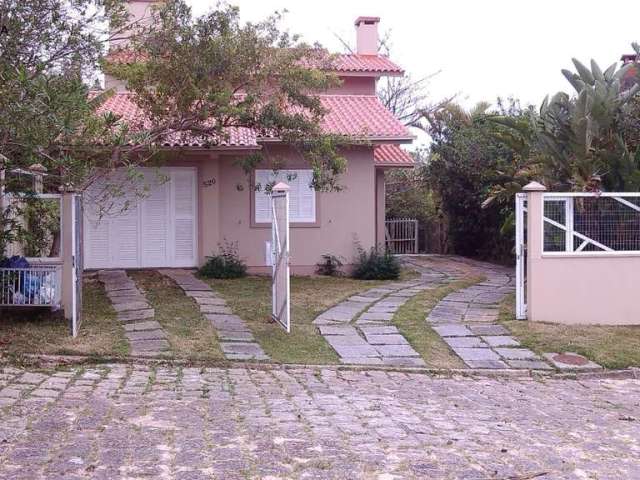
(107, 49), (404, 76)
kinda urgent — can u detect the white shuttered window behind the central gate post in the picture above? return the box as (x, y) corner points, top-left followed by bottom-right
(254, 170), (316, 223)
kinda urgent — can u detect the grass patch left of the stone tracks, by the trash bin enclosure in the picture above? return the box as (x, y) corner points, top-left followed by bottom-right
(0, 276), (129, 357)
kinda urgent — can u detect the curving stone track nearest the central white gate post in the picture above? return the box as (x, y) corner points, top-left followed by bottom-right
(313, 271), (445, 367)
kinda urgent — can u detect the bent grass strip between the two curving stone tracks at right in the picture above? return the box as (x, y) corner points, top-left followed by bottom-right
(393, 278), (481, 368)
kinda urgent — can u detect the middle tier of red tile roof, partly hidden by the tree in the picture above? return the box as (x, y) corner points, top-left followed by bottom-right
(93, 92), (412, 147)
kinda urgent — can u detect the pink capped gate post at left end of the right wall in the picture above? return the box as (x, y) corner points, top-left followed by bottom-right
(522, 182), (547, 321)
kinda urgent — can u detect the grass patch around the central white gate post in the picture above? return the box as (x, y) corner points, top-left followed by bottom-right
(207, 277), (383, 364)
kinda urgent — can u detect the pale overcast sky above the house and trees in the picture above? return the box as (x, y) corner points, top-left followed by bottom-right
(190, 0), (640, 144)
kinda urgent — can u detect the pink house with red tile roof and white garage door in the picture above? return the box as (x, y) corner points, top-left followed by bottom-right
(84, 1), (413, 274)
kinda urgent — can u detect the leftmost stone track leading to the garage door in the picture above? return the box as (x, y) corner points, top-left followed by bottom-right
(98, 270), (169, 356)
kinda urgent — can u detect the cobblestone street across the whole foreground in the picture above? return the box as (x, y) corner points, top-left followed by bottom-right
(0, 365), (640, 480)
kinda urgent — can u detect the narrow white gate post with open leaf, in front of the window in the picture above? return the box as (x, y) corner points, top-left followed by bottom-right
(271, 182), (291, 333)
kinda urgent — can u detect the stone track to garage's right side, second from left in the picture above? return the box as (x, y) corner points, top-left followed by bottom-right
(160, 269), (269, 360)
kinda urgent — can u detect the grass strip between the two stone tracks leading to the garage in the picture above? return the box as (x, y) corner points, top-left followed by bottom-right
(129, 270), (224, 360)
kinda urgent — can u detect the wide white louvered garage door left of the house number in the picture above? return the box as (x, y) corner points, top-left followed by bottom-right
(84, 167), (197, 269)
